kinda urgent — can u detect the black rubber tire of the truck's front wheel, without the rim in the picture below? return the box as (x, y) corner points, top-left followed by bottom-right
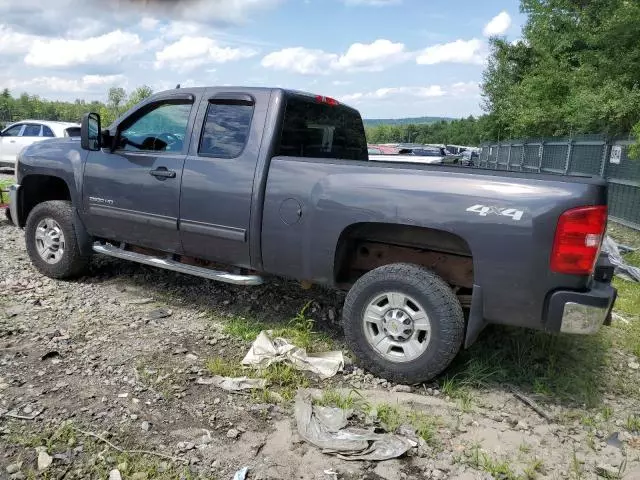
(25, 200), (90, 279)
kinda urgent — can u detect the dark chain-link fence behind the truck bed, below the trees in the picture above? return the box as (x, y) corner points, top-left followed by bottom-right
(478, 135), (640, 230)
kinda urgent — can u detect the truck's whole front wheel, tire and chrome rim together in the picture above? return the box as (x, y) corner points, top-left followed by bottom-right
(25, 200), (89, 278)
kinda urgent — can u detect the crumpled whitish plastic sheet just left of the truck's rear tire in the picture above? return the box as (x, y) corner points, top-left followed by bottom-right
(242, 330), (344, 380)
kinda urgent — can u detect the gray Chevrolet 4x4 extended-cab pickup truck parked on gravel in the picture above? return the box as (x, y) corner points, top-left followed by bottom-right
(10, 87), (616, 382)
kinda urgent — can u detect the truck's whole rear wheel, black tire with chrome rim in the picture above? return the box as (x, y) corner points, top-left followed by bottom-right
(343, 263), (464, 383)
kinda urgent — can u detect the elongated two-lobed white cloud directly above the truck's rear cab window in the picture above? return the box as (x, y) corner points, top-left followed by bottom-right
(262, 39), (410, 75)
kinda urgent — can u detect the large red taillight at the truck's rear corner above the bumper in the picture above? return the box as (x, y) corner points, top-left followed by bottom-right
(551, 205), (607, 275)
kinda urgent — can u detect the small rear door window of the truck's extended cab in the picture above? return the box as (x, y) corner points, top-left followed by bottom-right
(198, 100), (253, 158)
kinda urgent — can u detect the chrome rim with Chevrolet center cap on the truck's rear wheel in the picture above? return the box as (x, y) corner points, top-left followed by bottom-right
(363, 292), (431, 362)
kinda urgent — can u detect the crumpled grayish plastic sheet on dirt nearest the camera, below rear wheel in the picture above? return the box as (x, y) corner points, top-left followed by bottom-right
(295, 389), (419, 461)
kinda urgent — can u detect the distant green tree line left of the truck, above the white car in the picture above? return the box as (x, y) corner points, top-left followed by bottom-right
(0, 85), (153, 126)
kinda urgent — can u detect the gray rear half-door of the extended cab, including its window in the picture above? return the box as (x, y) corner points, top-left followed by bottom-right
(179, 88), (270, 267)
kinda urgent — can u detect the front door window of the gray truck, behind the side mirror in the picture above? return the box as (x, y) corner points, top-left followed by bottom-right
(119, 100), (193, 152)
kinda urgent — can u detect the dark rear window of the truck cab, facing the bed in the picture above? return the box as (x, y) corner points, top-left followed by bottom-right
(275, 93), (368, 161)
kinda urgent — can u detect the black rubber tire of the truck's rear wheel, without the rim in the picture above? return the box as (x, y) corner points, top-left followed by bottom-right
(343, 263), (465, 384)
